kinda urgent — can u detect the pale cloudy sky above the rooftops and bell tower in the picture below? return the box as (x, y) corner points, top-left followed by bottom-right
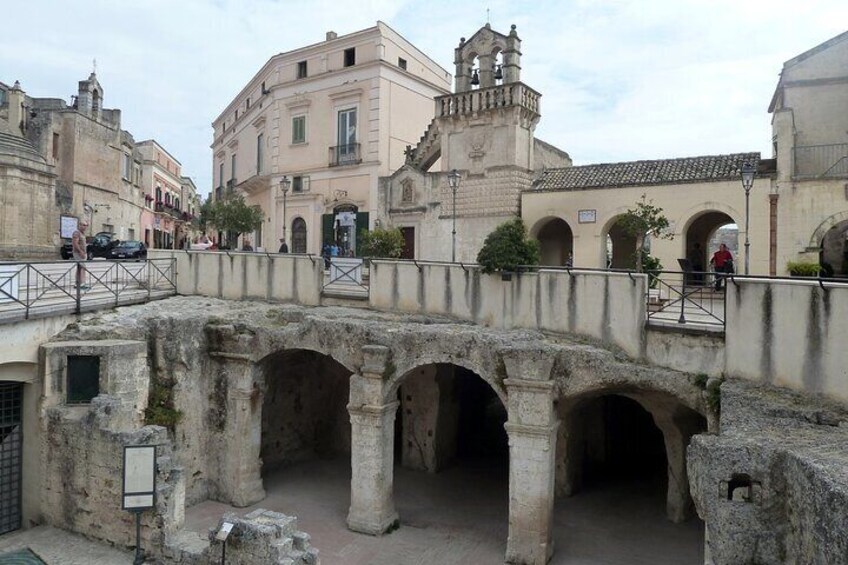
(0, 0), (848, 194)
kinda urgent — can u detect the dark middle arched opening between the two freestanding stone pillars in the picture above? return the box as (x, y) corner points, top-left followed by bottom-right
(394, 363), (509, 548)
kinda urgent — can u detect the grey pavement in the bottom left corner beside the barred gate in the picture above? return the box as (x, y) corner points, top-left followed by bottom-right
(0, 524), (134, 565)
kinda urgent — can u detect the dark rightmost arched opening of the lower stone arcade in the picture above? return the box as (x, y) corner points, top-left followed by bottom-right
(554, 390), (706, 563)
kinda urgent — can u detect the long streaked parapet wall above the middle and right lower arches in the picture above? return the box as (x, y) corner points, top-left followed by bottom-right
(370, 261), (646, 357)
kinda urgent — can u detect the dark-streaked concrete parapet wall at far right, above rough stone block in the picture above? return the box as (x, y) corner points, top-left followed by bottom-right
(725, 279), (848, 401)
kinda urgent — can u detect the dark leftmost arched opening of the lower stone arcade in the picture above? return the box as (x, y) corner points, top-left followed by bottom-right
(257, 349), (351, 494)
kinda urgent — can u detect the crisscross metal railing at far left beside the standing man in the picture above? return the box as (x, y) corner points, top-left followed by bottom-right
(0, 257), (177, 324)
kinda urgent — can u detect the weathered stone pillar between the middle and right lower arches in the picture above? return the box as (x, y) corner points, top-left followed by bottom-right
(504, 349), (559, 565)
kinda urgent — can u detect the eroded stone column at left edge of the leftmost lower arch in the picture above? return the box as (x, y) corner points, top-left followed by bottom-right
(210, 353), (265, 507)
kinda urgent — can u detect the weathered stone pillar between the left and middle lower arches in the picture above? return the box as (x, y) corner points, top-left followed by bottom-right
(347, 345), (398, 535)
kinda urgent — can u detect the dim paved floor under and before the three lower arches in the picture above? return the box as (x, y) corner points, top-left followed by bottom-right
(186, 460), (703, 565)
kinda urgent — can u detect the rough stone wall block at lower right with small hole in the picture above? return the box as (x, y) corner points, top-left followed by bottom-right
(688, 380), (848, 563)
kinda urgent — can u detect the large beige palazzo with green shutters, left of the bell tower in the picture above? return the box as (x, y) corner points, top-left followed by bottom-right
(212, 22), (451, 253)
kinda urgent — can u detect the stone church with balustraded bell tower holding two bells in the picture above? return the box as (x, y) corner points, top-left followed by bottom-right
(381, 24), (548, 262)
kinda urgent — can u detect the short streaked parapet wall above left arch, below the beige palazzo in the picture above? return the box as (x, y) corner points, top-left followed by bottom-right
(149, 249), (324, 306)
